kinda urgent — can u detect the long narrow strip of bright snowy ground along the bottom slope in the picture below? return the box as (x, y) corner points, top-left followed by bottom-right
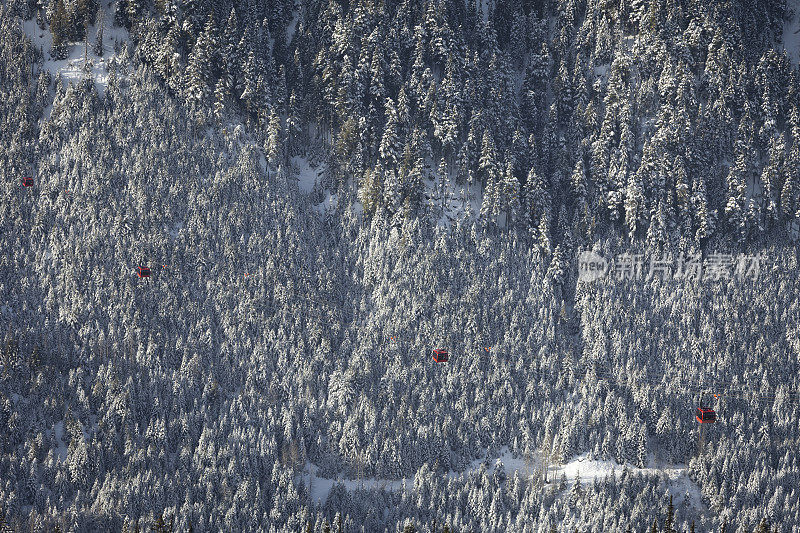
(303, 447), (703, 509)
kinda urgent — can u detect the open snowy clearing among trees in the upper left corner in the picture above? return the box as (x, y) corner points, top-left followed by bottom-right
(22, 3), (129, 106)
